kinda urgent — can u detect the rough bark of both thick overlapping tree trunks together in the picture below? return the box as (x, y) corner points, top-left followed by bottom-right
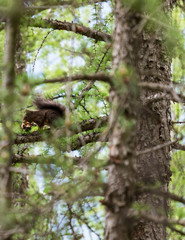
(105, 0), (171, 240)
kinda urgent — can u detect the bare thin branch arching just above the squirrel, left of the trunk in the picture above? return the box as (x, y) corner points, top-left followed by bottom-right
(38, 73), (112, 85)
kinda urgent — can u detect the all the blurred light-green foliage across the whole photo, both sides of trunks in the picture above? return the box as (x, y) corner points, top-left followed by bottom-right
(0, 0), (185, 240)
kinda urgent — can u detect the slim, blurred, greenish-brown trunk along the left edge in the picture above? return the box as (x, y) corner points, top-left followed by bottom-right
(0, 0), (20, 240)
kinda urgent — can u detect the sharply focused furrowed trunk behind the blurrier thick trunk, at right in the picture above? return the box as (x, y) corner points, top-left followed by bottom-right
(134, 29), (171, 240)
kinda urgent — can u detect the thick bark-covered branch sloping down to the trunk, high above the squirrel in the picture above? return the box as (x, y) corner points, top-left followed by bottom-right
(29, 19), (112, 42)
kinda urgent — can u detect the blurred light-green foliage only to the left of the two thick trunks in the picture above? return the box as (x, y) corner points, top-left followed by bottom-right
(0, 1), (113, 240)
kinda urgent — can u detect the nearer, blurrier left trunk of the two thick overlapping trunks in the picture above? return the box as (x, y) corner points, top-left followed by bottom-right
(105, 1), (137, 240)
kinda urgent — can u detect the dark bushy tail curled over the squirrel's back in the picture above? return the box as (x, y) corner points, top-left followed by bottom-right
(33, 98), (65, 116)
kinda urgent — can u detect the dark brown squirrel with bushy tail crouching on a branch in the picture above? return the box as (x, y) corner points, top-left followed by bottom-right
(21, 98), (65, 130)
